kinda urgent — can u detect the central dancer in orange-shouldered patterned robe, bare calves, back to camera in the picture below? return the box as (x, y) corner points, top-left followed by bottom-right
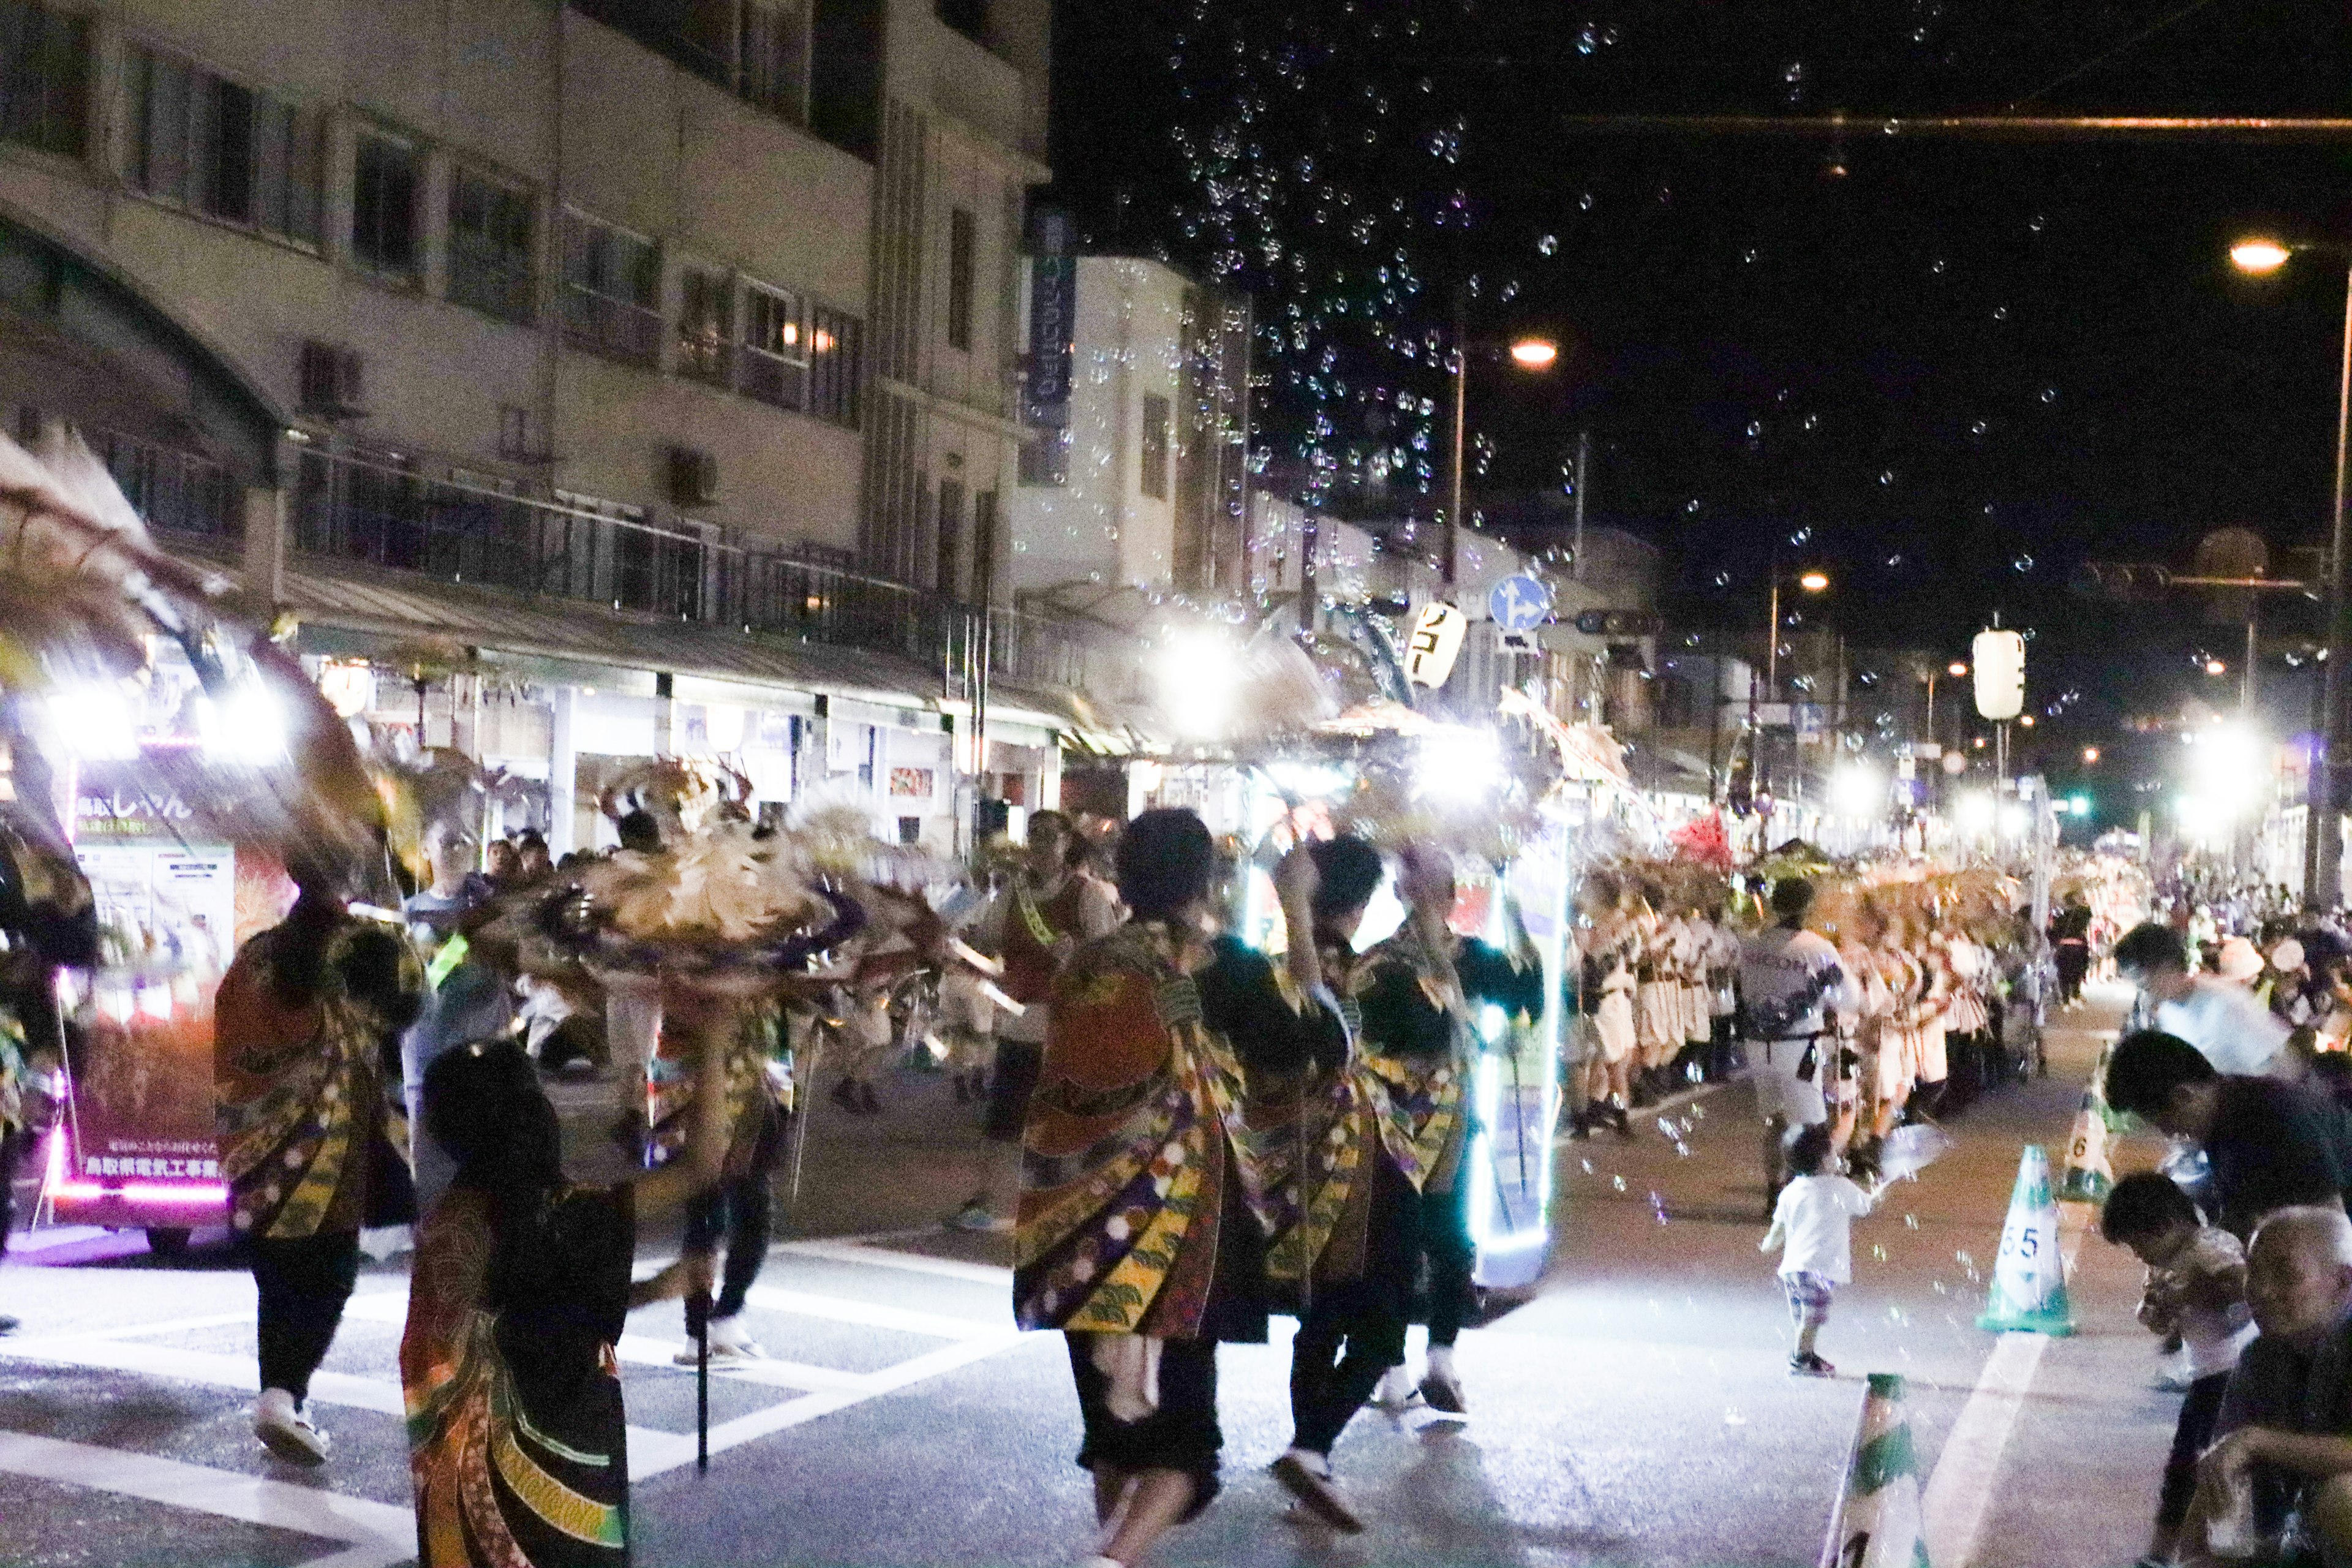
(1014, 811), (1348, 1568)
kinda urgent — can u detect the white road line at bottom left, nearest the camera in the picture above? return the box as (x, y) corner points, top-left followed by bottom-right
(0, 1431), (417, 1568)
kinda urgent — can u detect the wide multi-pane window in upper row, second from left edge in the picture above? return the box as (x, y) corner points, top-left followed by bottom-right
(123, 47), (322, 249)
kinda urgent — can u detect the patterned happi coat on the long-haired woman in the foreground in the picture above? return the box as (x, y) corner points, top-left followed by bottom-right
(400, 1185), (633, 1568)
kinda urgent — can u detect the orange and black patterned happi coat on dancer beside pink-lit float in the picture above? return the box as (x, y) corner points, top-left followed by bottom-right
(214, 919), (423, 1242)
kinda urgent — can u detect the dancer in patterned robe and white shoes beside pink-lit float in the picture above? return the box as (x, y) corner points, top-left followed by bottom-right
(214, 865), (423, 1464)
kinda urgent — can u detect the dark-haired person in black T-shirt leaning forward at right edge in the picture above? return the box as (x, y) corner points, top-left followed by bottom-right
(2105, 1030), (2352, 1237)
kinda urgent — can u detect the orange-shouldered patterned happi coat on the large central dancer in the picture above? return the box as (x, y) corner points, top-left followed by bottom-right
(1014, 924), (1261, 1340)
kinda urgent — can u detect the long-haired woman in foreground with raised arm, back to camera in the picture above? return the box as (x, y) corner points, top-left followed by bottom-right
(400, 990), (727, 1568)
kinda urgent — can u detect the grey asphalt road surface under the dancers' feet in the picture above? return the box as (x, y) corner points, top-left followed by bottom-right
(0, 995), (2178, 1568)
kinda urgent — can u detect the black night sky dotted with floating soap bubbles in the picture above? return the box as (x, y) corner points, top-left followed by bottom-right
(1051, 0), (2352, 785)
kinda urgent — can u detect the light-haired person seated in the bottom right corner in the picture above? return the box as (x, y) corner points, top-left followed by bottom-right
(2180, 1206), (2352, 1568)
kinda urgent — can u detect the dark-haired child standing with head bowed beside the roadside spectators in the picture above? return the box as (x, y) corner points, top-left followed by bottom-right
(2098, 1170), (2253, 1563)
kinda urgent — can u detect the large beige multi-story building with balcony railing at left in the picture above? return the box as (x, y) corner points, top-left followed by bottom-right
(0, 0), (1054, 844)
